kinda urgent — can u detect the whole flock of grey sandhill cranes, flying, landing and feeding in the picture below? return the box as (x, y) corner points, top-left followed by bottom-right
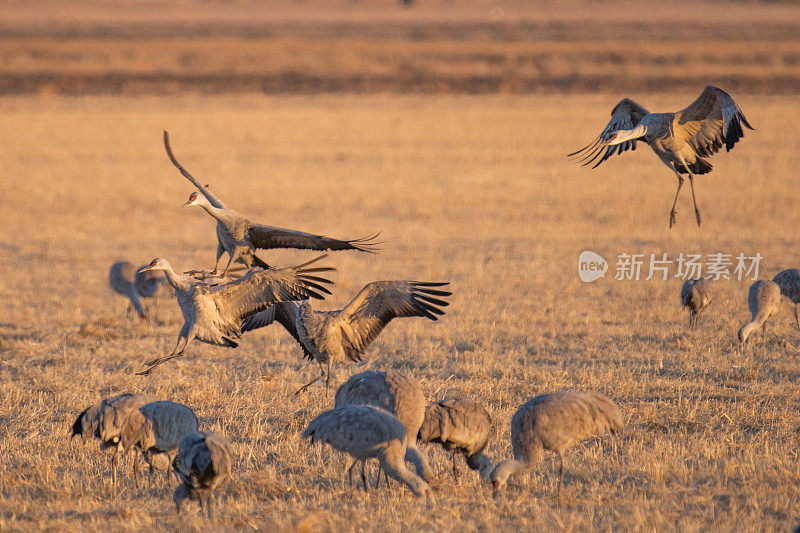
(72, 86), (780, 516)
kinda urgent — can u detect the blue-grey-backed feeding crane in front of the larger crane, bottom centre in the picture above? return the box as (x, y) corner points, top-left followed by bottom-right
(302, 405), (431, 496)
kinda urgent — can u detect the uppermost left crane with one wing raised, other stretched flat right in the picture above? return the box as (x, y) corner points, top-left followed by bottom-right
(164, 131), (378, 275)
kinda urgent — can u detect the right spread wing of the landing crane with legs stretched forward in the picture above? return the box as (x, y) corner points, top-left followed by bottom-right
(206, 255), (336, 332)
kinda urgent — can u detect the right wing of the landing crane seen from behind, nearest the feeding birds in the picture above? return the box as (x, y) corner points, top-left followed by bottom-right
(338, 281), (452, 361)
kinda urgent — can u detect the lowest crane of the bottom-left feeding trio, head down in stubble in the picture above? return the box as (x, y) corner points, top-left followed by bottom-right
(172, 431), (233, 518)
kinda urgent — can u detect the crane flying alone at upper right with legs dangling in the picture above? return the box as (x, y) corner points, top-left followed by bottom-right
(569, 85), (753, 228)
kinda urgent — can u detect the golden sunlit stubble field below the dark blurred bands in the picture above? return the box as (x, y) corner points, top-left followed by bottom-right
(0, 93), (800, 531)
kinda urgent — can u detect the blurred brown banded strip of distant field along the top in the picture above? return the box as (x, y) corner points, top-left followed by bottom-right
(0, 0), (800, 95)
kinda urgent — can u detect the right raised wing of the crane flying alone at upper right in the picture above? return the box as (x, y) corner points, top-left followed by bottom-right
(673, 85), (753, 157)
